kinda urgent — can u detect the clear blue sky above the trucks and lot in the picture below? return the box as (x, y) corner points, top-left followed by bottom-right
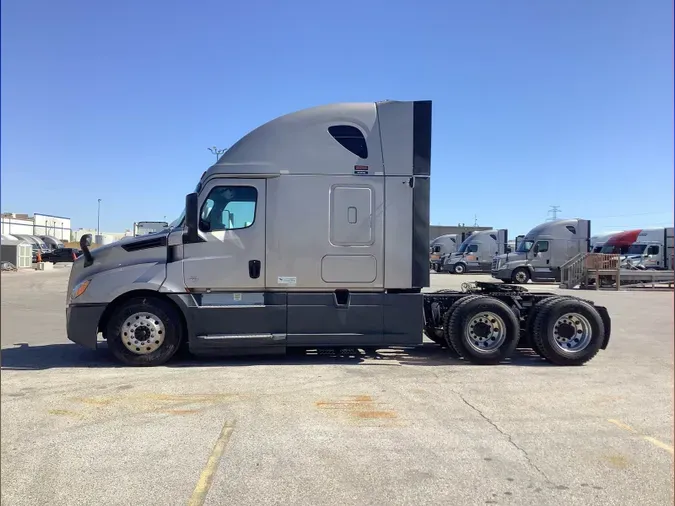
(1, 0), (673, 235)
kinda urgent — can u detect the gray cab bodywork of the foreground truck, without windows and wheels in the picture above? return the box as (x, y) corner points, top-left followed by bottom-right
(69, 101), (431, 358)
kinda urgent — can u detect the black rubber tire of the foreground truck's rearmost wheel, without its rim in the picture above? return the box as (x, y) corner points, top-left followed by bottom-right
(532, 297), (605, 366)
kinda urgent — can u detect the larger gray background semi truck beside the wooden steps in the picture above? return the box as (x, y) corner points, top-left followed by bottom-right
(491, 218), (591, 284)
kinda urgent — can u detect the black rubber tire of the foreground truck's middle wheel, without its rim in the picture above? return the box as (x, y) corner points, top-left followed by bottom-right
(446, 295), (520, 365)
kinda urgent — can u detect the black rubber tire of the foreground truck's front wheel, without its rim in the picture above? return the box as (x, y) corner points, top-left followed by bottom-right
(106, 297), (183, 366)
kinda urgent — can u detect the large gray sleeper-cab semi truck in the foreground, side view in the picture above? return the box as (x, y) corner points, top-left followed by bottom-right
(66, 101), (611, 366)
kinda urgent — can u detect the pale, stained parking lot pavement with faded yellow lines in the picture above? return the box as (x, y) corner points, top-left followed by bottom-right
(0, 267), (674, 506)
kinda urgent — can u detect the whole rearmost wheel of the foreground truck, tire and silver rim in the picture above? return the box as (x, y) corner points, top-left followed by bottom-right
(532, 298), (605, 365)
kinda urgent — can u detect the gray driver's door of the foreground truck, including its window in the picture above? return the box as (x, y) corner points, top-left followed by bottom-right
(183, 178), (266, 293)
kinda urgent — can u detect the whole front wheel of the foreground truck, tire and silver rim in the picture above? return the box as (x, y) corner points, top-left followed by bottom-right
(106, 297), (182, 366)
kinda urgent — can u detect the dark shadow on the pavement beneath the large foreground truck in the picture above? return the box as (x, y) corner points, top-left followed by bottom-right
(0, 343), (550, 371)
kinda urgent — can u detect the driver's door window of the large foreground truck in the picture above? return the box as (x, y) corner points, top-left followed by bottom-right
(199, 186), (258, 232)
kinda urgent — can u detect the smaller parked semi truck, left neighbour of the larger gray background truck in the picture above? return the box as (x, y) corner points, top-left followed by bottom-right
(441, 229), (509, 274)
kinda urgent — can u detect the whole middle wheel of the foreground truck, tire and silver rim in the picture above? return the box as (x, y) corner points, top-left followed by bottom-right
(446, 295), (520, 365)
